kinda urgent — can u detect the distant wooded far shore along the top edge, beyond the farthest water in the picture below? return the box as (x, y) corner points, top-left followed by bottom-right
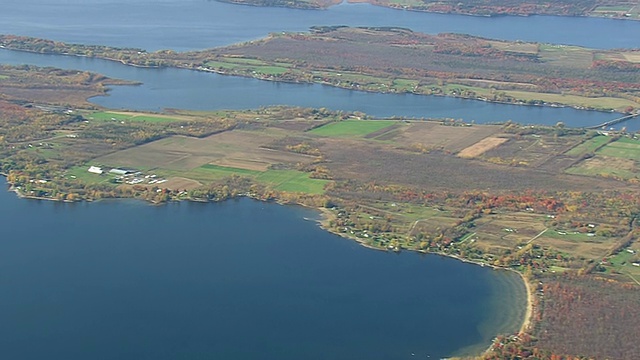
(219, 0), (640, 20)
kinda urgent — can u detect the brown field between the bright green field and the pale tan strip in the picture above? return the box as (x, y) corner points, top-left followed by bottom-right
(393, 121), (502, 153)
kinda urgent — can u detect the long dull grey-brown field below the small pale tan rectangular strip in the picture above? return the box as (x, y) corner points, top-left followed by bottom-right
(320, 139), (636, 191)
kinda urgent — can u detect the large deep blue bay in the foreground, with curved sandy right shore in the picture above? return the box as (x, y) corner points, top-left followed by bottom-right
(0, 179), (525, 360)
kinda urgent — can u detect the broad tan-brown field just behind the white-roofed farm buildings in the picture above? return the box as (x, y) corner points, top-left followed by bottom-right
(96, 131), (314, 171)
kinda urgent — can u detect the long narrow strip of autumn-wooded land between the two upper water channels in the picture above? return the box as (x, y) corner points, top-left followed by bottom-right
(0, 26), (640, 114)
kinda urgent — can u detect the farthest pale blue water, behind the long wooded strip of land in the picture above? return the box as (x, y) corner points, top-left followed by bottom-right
(0, 0), (640, 50)
